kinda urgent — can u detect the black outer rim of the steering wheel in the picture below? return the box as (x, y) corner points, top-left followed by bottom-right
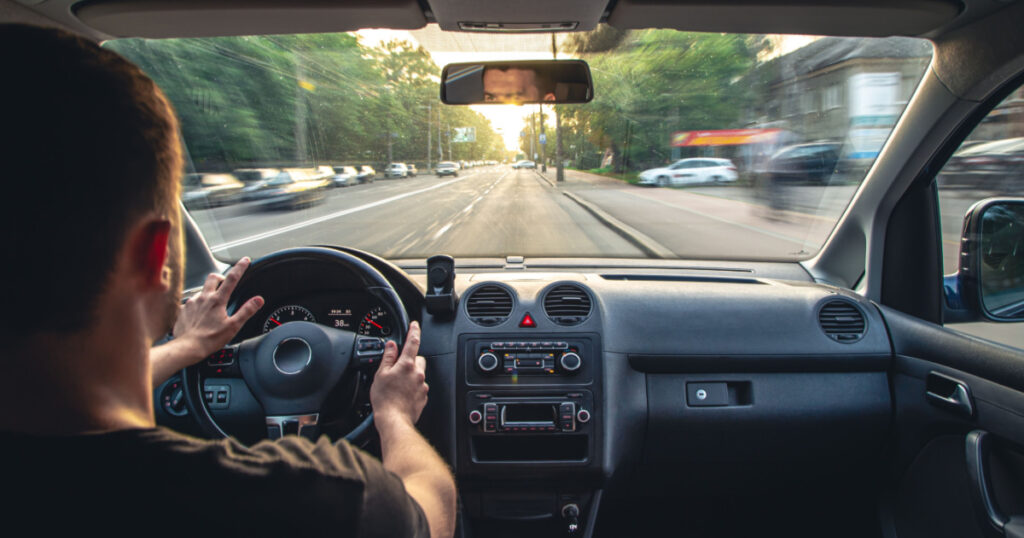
(181, 247), (410, 443)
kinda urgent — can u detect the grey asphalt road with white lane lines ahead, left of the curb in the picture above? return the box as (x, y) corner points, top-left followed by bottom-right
(193, 167), (644, 259)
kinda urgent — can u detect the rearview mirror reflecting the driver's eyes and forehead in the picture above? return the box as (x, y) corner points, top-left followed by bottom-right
(441, 59), (594, 105)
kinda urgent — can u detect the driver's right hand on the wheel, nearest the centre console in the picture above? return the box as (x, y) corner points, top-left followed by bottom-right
(370, 322), (428, 428)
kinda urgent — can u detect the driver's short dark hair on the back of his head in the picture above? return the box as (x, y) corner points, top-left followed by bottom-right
(0, 25), (182, 343)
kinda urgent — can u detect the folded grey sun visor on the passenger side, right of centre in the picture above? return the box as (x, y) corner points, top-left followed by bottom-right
(608, 0), (962, 37)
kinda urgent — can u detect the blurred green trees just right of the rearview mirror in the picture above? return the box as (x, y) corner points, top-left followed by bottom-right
(544, 27), (768, 171)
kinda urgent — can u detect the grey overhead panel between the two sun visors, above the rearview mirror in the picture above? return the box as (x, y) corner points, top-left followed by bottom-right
(429, 0), (608, 33)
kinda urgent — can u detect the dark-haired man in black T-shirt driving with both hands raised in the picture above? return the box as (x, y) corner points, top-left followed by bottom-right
(0, 25), (456, 537)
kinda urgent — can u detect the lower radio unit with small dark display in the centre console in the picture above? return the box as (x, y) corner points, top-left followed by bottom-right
(467, 390), (593, 433)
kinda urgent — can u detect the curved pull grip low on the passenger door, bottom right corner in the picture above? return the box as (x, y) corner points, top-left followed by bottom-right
(966, 429), (1024, 538)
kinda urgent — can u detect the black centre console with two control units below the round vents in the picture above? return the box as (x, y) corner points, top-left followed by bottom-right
(456, 333), (602, 537)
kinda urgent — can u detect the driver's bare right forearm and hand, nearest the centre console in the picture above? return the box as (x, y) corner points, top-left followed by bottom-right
(370, 322), (456, 538)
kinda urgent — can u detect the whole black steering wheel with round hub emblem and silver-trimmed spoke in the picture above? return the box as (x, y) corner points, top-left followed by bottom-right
(182, 247), (410, 444)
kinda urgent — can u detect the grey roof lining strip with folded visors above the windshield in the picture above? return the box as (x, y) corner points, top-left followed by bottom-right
(0, 0), (1007, 39)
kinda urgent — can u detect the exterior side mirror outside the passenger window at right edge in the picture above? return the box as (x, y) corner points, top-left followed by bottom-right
(944, 199), (1024, 322)
